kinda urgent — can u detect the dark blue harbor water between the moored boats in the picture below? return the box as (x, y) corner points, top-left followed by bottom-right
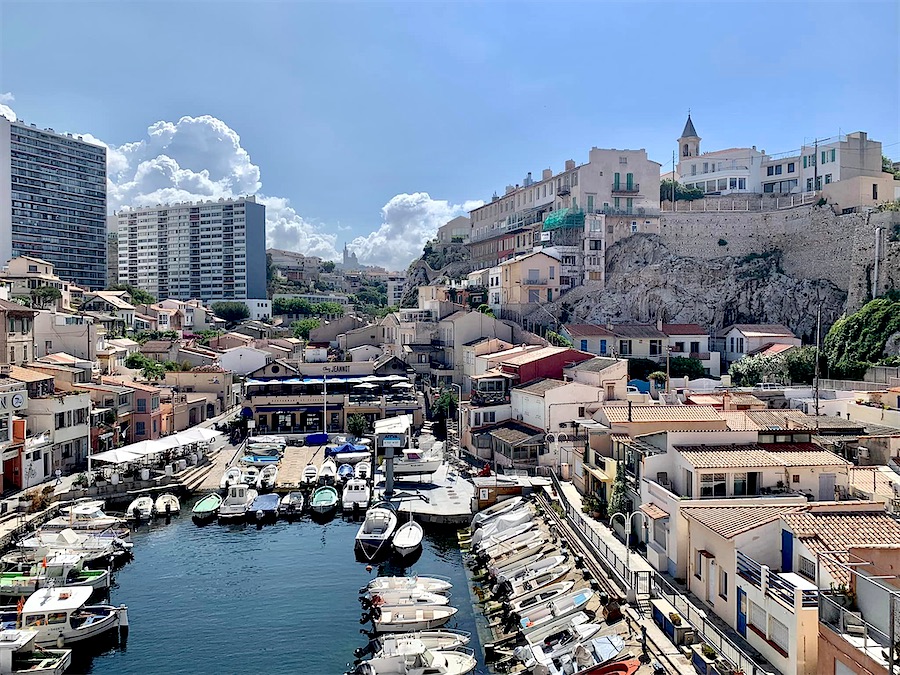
(71, 516), (481, 675)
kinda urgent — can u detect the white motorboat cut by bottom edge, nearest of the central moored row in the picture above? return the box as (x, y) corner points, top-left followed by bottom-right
(351, 637), (477, 675)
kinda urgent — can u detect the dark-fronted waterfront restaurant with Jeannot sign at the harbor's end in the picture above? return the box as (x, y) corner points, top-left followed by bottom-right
(242, 354), (424, 433)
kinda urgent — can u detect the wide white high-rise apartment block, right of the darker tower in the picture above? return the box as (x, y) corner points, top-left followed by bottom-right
(116, 197), (266, 303)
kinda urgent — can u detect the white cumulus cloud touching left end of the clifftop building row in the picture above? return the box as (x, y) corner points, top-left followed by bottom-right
(349, 192), (481, 270)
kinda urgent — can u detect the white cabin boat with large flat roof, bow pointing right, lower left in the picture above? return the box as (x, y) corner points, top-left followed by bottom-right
(0, 586), (128, 647)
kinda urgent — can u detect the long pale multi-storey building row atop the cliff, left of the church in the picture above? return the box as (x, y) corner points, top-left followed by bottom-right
(469, 148), (660, 267)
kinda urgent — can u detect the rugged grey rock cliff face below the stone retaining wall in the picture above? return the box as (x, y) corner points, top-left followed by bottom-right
(544, 234), (847, 342)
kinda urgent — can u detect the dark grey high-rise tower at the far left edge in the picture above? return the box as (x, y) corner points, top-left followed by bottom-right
(0, 118), (106, 289)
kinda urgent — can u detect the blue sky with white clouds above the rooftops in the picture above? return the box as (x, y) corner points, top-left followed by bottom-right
(0, 0), (900, 269)
